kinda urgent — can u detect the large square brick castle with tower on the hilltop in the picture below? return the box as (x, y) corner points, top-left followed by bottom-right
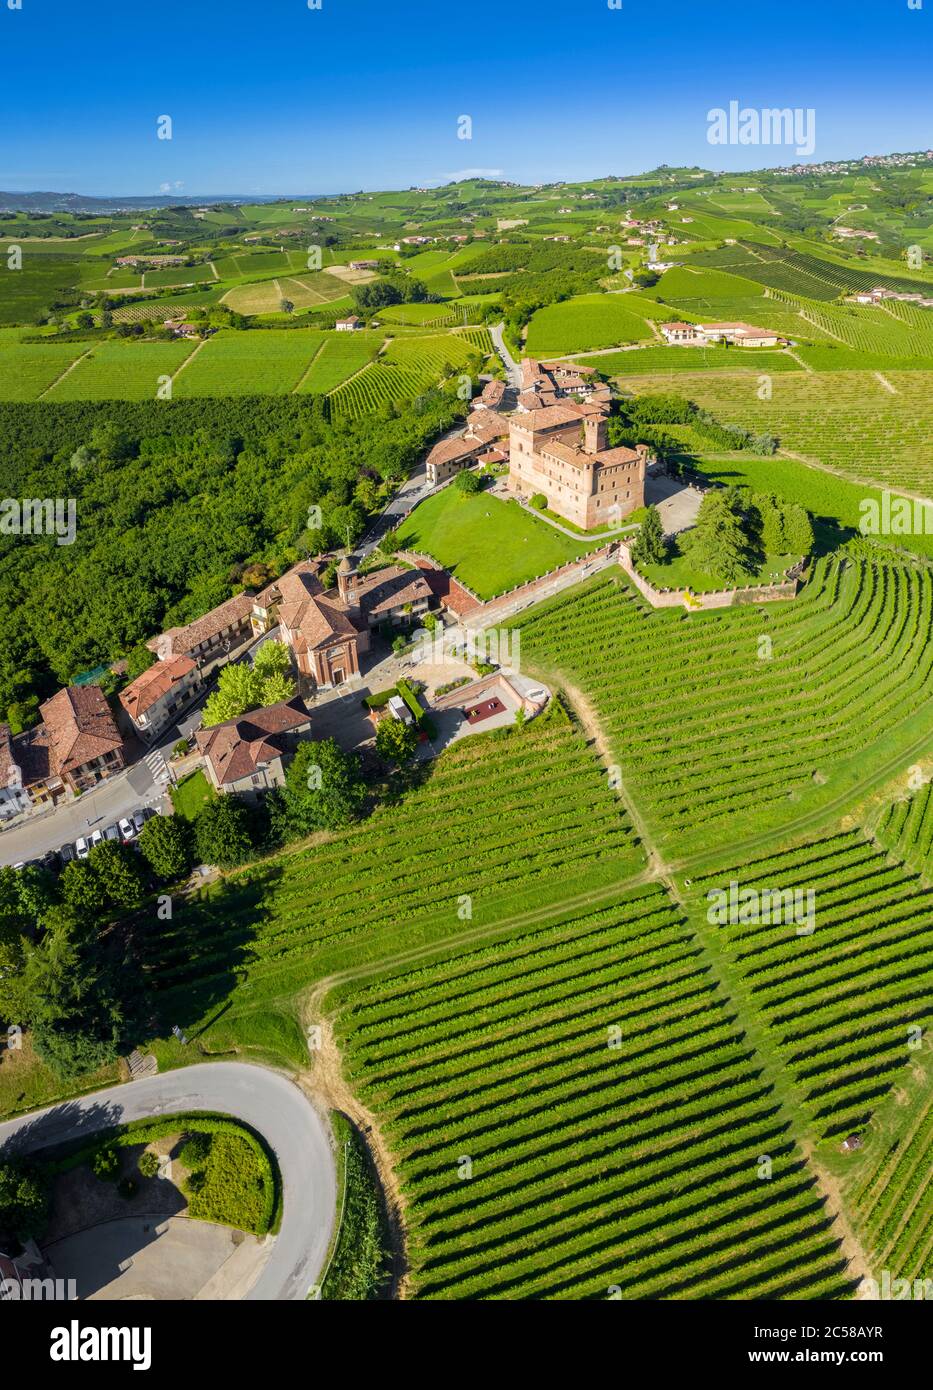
(509, 380), (648, 530)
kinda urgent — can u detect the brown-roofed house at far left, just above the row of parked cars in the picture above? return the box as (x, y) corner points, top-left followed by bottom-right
(39, 685), (127, 792)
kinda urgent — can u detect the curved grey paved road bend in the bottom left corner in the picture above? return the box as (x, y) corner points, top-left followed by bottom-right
(0, 1062), (336, 1300)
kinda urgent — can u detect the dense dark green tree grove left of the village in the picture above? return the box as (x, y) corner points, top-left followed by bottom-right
(0, 391), (464, 730)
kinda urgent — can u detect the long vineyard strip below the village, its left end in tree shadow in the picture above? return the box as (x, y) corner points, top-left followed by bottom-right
(140, 706), (644, 1038)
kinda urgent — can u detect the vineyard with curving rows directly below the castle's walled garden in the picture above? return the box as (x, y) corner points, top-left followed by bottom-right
(519, 557), (933, 855)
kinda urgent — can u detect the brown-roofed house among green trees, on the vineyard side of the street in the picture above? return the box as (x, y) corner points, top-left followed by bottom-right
(195, 696), (311, 798)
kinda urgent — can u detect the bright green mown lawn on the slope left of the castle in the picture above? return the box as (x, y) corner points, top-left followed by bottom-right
(399, 485), (601, 599)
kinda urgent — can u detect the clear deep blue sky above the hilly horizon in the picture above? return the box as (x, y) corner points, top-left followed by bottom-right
(0, 0), (933, 196)
